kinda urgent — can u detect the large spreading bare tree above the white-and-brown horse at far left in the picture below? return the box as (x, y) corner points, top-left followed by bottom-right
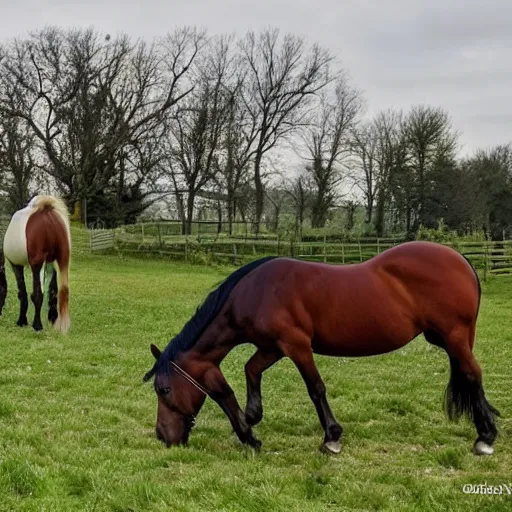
(0, 28), (204, 222)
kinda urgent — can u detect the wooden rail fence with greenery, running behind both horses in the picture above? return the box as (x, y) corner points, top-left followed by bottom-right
(0, 216), (512, 279)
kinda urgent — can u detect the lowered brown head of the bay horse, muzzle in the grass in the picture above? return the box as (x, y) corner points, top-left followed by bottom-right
(144, 344), (205, 447)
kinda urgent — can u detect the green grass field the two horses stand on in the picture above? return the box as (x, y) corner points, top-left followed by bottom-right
(0, 256), (512, 512)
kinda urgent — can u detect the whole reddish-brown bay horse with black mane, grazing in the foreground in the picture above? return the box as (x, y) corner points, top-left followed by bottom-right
(144, 242), (499, 455)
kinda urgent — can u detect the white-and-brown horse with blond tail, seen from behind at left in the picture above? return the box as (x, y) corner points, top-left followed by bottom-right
(0, 196), (71, 334)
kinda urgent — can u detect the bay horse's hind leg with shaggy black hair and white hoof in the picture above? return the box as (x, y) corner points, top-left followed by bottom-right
(438, 328), (499, 455)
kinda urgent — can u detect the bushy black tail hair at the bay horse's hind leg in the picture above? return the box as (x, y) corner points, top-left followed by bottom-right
(445, 358), (500, 443)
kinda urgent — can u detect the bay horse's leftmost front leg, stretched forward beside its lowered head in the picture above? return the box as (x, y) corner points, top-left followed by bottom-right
(203, 367), (261, 449)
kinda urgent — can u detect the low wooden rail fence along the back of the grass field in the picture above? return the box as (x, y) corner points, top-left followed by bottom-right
(90, 230), (512, 279)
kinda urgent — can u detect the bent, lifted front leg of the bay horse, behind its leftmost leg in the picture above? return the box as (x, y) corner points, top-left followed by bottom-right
(245, 348), (283, 426)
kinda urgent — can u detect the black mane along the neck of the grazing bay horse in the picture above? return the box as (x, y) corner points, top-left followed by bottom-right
(144, 256), (275, 381)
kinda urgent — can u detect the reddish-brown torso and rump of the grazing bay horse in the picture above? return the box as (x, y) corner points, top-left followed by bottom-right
(229, 242), (479, 356)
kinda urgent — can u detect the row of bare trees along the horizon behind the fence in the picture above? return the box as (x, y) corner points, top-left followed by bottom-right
(0, 27), (512, 239)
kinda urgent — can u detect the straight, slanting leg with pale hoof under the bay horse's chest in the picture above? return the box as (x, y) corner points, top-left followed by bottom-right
(281, 339), (343, 454)
